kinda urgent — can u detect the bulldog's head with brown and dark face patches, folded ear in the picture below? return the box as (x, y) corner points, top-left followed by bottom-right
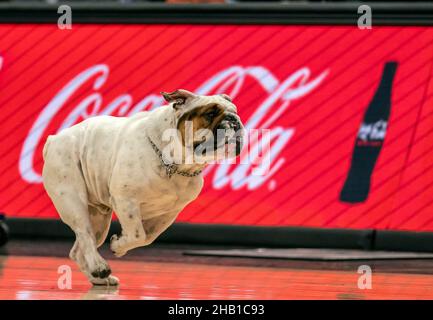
(161, 89), (244, 161)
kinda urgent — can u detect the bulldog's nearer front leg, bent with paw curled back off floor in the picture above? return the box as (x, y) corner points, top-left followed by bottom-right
(110, 198), (146, 257)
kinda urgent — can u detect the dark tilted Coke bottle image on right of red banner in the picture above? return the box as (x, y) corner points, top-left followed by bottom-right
(340, 62), (397, 203)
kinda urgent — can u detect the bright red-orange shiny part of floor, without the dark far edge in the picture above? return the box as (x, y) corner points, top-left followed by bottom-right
(0, 255), (433, 299)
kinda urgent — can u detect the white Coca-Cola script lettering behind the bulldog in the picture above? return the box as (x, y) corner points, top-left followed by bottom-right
(19, 64), (329, 190)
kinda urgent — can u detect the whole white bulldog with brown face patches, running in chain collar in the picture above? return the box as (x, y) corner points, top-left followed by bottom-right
(42, 90), (243, 285)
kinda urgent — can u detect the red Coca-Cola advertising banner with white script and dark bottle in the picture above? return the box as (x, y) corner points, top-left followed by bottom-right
(0, 24), (433, 231)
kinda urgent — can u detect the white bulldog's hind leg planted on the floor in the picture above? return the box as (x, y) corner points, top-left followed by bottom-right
(42, 134), (115, 284)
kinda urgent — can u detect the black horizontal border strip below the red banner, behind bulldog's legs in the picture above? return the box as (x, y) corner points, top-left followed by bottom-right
(6, 218), (433, 252)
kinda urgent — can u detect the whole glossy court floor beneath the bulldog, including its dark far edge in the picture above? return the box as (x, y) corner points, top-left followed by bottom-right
(0, 240), (433, 300)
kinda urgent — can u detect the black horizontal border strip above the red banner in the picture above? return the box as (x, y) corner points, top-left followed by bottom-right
(0, 1), (433, 27)
